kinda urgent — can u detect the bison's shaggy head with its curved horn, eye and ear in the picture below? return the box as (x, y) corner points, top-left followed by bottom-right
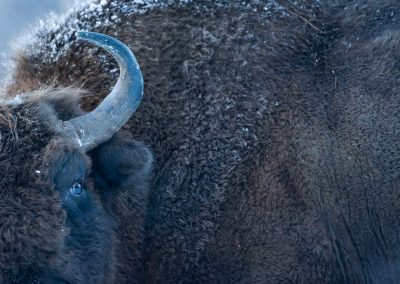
(0, 33), (152, 283)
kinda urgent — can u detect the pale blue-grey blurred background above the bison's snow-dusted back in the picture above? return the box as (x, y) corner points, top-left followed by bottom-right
(0, 0), (71, 53)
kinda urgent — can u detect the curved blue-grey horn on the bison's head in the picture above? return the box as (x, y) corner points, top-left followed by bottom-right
(60, 32), (143, 151)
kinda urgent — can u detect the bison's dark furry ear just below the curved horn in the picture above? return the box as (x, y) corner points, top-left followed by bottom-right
(89, 131), (153, 190)
